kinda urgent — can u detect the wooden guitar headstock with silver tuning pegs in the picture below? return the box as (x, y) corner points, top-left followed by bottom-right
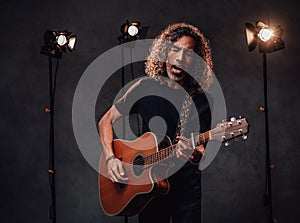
(211, 118), (249, 146)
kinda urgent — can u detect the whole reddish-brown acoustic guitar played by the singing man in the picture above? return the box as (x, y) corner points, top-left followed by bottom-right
(99, 118), (248, 216)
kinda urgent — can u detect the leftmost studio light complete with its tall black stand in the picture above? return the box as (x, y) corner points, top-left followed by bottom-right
(41, 30), (76, 223)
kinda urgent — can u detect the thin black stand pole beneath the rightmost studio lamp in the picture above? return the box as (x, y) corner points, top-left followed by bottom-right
(262, 52), (274, 223)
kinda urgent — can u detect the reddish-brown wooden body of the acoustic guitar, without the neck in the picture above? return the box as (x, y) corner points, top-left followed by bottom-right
(99, 133), (169, 216)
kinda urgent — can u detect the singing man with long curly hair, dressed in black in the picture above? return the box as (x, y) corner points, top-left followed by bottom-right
(98, 23), (212, 223)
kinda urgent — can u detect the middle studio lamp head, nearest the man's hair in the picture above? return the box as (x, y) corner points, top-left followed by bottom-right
(118, 20), (148, 44)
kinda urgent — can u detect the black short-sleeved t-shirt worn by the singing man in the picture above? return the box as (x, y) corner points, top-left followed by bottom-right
(115, 77), (211, 141)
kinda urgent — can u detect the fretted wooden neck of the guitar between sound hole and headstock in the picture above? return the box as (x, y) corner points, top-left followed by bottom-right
(141, 130), (211, 165)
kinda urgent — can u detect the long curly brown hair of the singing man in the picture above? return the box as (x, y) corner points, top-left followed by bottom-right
(145, 23), (213, 91)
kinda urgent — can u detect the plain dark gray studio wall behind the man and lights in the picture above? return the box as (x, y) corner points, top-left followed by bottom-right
(0, 0), (300, 223)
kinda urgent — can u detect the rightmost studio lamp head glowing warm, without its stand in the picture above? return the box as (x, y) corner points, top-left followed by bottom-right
(245, 22), (285, 53)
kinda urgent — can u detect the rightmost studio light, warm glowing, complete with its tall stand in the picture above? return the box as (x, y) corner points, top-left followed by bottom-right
(245, 22), (284, 223)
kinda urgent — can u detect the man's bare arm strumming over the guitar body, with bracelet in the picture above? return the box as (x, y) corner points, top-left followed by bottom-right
(98, 105), (127, 182)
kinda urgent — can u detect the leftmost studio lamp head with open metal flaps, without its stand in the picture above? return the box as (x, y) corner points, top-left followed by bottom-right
(41, 30), (76, 58)
